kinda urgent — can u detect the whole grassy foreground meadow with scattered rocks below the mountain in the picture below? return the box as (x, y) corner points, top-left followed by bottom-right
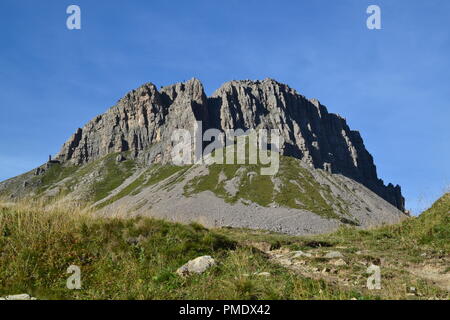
(0, 194), (450, 299)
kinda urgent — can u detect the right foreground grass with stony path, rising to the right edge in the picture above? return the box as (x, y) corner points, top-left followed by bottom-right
(216, 193), (450, 300)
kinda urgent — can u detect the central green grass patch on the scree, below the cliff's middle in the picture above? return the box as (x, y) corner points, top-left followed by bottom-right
(185, 156), (347, 218)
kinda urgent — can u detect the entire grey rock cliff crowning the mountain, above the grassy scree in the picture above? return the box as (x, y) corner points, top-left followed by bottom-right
(56, 79), (404, 211)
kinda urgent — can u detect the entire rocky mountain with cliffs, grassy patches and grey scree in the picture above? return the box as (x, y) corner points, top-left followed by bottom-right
(0, 79), (405, 234)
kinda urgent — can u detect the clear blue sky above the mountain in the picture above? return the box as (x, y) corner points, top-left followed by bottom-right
(0, 0), (450, 212)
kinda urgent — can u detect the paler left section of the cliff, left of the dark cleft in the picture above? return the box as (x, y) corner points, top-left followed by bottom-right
(56, 79), (208, 164)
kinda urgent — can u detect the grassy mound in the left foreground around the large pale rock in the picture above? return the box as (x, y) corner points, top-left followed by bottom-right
(0, 201), (363, 299)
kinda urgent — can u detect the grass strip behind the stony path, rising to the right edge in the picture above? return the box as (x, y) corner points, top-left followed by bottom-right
(223, 193), (450, 261)
